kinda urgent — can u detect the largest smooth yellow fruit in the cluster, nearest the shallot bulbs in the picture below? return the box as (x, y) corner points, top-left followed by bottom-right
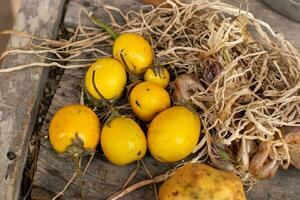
(147, 106), (200, 162)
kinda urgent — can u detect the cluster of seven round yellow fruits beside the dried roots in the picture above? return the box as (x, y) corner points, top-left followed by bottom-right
(49, 33), (201, 165)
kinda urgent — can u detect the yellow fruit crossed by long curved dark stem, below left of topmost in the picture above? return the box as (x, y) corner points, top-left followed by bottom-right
(85, 58), (127, 100)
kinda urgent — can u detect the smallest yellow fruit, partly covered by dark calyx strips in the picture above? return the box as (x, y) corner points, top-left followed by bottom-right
(144, 67), (170, 88)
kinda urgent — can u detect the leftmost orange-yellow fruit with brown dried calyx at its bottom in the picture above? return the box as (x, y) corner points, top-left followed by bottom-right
(49, 104), (100, 153)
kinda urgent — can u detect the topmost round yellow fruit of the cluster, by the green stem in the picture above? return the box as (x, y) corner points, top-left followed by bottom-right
(113, 33), (154, 74)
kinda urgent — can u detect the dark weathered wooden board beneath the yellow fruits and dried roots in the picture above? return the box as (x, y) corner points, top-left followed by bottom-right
(31, 0), (300, 200)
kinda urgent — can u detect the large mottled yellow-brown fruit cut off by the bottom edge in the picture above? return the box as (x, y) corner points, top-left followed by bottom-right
(159, 163), (246, 200)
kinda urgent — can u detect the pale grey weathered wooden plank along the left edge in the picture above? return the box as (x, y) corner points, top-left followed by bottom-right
(0, 0), (65, 200)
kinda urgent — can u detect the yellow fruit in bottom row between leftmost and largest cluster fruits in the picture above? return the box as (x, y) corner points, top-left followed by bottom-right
(101, 116), (147, 165)
